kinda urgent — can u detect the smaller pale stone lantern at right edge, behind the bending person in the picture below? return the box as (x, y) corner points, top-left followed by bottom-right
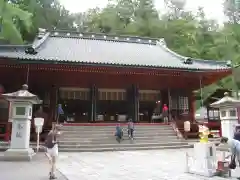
(210, 93), (240, 138)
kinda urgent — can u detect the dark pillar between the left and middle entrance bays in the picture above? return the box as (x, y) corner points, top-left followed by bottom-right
(89, 84), (98, 122)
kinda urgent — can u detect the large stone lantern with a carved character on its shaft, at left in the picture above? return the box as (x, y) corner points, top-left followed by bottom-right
(2, 85), (41, 161)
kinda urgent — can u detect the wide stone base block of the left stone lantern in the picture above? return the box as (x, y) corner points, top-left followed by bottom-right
(3, 148), (35, 161)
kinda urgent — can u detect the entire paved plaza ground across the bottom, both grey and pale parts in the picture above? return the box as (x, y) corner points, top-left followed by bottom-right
(0, 149), (240, 180)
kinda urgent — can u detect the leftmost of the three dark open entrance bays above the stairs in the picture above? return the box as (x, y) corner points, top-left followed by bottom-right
(58, 88), (91, 123)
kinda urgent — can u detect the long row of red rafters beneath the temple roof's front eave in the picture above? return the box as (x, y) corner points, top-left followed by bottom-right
(0, 64), (229, 78)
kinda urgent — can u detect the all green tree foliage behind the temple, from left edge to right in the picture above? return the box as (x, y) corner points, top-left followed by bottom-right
(0, 0), (240, 105)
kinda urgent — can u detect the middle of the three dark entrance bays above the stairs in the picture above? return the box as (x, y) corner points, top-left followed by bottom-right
(96, 89), (129, 122)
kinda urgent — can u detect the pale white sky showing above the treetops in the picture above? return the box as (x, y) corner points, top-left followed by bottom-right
(59, 0), (224, 22)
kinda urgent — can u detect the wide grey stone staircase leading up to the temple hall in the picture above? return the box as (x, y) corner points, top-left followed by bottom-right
(55, 125), (192, 152)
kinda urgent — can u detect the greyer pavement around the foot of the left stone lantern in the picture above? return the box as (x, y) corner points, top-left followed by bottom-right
(0, 153), (67, 180)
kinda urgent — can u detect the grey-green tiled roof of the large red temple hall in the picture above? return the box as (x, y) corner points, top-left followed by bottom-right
(0, 31), (232, 71)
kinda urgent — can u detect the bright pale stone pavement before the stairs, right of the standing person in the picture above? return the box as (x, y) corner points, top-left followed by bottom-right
(58, 149), (240, 180)
